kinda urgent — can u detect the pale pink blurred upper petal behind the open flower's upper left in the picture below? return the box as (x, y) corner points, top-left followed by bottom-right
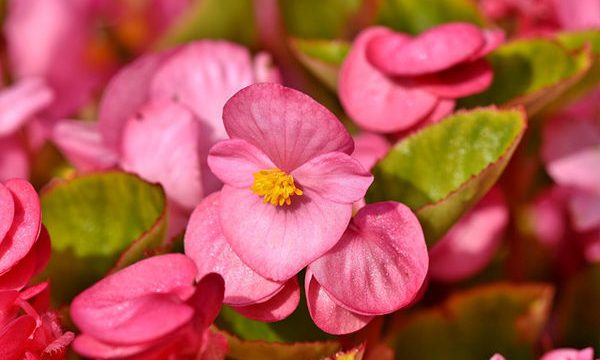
(150, 40), (255, 141)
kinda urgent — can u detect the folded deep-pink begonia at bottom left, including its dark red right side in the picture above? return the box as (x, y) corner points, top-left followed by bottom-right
(71, 254), (224, 359)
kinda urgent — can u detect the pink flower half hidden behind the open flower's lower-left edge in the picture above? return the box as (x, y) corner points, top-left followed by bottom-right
(184, 192), (300, 321)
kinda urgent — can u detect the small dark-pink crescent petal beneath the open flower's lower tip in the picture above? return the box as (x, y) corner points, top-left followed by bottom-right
(233, 277), (300, 322)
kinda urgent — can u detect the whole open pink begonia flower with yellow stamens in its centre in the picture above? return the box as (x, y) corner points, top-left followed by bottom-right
(208, 83), (373, 281)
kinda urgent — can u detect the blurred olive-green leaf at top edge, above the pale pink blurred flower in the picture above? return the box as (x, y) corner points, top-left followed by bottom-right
(157, 0), (256, 48)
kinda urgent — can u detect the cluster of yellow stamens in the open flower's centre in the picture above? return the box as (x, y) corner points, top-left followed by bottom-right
(250, 168), (303, 206)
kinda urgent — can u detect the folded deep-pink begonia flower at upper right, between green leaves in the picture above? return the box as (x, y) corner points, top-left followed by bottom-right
(339, 23), (504, 133)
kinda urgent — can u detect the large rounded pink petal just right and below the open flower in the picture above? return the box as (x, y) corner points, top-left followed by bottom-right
(309, 201), (429, 315)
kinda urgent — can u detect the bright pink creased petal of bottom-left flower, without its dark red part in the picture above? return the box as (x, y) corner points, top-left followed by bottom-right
(71, 254), (196, 345)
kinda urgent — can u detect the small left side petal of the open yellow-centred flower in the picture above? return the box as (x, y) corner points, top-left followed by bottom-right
(208, 139), (277, 188)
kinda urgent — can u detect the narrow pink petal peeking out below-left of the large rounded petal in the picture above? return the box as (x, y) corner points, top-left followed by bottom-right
(304, 270), (373, 335)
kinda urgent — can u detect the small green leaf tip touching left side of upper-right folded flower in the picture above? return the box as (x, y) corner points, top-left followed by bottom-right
(290, 38), (350, 91)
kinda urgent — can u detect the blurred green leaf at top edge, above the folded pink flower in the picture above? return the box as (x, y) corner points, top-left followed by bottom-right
(377, 0), (484, 34)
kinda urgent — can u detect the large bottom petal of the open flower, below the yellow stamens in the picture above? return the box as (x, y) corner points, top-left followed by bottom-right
(219, 185), (352, 281)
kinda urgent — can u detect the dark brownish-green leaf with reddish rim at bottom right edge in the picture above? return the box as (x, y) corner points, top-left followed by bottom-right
(387, 284), (553, 360)
